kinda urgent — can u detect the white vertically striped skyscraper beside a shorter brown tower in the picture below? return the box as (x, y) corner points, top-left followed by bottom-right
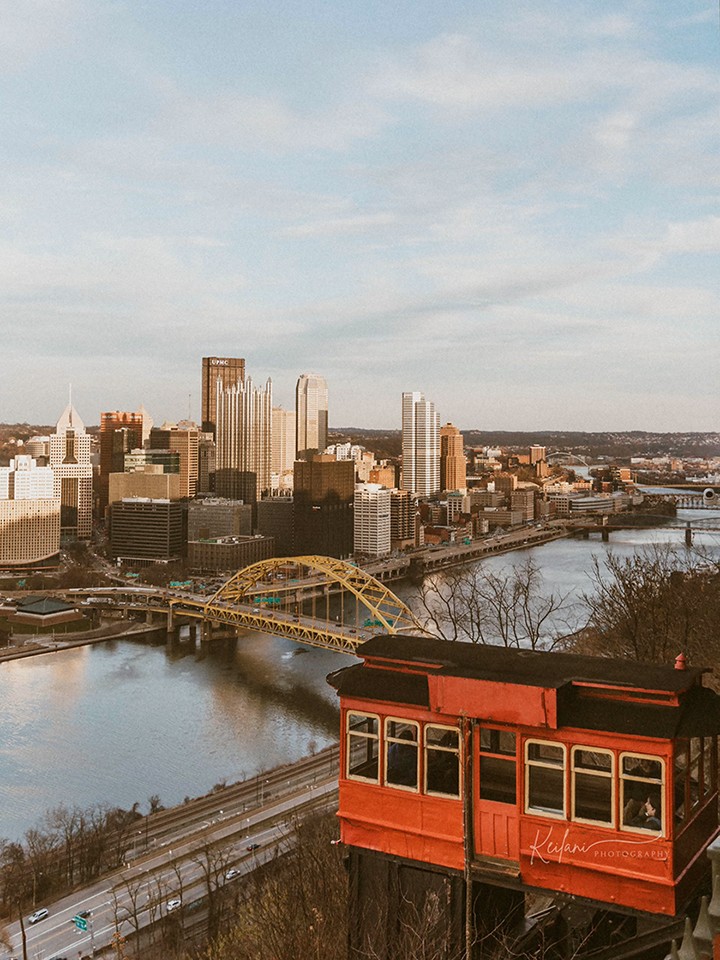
(402, 391), (440, 497)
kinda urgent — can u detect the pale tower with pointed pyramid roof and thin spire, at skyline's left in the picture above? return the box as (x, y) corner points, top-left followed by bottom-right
(49, 403), (93, 540)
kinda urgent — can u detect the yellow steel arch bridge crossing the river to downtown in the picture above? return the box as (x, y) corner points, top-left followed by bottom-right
(150, 556), (425, 653)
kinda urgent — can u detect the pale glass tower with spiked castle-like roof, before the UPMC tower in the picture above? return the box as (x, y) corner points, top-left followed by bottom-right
(215, 377), (272, 503)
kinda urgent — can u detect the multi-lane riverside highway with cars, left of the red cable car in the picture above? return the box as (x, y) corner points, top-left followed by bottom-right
(0, 748), (337, 960)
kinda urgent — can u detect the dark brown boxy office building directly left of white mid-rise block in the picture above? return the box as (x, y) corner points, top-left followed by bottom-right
(293, 454), (355, 558)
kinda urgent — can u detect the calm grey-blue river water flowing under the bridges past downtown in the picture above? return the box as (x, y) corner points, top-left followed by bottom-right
(0, 511), (720, 840)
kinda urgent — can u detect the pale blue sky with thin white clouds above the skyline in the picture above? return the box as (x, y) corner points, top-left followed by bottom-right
(0, 0), (720, 431)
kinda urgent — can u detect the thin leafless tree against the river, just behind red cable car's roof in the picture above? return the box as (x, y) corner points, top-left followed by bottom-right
(418, 557), (569, 650)
